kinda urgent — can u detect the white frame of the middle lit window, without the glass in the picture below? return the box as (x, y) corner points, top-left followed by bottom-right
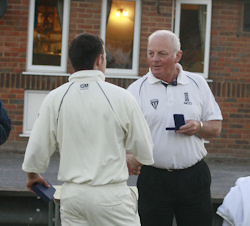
(100, 0), (141, 78)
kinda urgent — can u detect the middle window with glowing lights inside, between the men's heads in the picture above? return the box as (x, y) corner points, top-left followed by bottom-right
(101, 0), (141, 77)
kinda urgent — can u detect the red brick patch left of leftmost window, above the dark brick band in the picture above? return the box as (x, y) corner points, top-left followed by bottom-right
(0, 0), (29, 73)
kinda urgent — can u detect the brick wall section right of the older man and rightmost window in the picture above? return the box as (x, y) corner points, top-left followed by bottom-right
(208, 0), (250, 158)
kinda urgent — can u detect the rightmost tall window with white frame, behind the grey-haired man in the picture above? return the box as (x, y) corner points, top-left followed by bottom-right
(175, 0), (212, 78)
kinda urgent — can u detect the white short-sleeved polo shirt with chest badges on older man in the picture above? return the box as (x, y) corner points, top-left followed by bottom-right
(128, 64), (222, 169)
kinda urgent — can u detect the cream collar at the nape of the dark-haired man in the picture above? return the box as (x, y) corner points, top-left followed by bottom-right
(69, 70), (105, 82)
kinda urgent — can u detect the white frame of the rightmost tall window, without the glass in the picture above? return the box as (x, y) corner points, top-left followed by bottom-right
(174, 0), (212, 79)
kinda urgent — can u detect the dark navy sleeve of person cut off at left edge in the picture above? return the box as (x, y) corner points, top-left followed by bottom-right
(0, 101), (11, 145)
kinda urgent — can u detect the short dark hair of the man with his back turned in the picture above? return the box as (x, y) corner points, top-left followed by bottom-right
(69, 33), (104, 71)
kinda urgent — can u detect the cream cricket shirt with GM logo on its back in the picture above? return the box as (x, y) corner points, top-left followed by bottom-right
(22, 70), (153, 185)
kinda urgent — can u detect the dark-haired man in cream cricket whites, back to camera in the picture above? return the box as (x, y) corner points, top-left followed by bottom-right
(22, 34), (153, 226)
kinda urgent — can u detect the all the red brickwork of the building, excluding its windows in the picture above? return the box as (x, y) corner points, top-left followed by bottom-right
(0, 0), (250, 158)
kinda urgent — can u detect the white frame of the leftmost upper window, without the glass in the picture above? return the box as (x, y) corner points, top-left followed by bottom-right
(26, 0), (70, 73)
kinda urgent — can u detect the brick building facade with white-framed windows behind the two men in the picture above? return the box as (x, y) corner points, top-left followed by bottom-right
(0, 0), (250, 158)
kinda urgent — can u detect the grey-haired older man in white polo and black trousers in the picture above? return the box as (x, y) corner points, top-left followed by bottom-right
(128, 30), (222, 226)
